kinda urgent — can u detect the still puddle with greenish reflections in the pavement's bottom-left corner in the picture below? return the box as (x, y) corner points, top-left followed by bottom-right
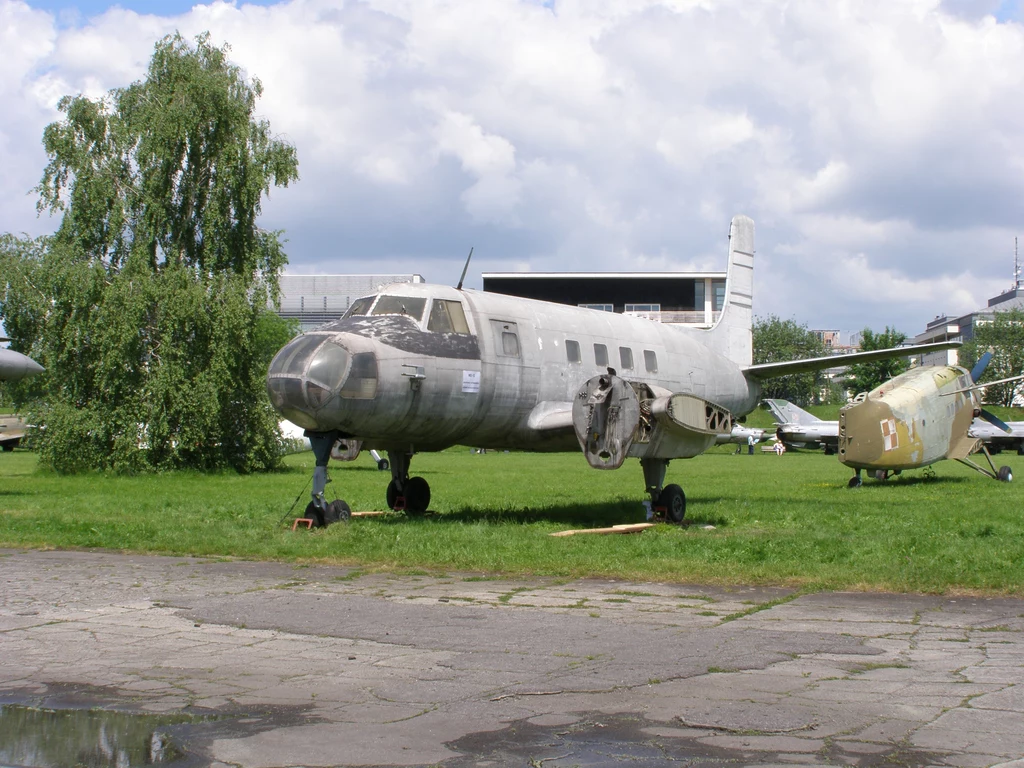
(0, 705), (208, 768)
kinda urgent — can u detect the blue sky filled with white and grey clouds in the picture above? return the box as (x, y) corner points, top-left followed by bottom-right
(6, 0), (1024, 337)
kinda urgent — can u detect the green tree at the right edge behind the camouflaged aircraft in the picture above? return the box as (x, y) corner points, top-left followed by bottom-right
(959, 309), (1024, 407)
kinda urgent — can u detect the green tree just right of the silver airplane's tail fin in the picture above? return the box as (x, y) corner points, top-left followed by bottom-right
(754, 314), (827, 406)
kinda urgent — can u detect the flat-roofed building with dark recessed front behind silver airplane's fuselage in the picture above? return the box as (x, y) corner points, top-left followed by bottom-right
(483, 272), (725, 327)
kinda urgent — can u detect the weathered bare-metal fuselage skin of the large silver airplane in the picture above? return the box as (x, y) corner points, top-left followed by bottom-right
(267, 284), (759, 455)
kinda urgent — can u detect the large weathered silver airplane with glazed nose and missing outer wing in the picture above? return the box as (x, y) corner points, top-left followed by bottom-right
(267, 216), (956, 524)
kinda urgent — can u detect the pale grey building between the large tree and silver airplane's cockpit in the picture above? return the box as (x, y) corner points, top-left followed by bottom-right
(278, 274), (423, 331)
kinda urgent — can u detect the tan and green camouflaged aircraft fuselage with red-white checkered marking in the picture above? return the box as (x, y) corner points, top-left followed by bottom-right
(839, 352), (1024, 487)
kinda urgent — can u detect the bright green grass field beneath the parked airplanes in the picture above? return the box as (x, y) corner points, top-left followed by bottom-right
(0, 438), (1024, 595)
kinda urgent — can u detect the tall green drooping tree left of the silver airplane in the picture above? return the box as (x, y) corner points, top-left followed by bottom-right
(0, 35), (298, 472)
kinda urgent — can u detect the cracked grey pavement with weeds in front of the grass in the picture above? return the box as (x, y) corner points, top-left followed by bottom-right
(0, 551), (1024, 768)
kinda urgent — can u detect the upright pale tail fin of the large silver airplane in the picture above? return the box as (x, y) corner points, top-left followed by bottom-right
(708, 216), (754, 367)
